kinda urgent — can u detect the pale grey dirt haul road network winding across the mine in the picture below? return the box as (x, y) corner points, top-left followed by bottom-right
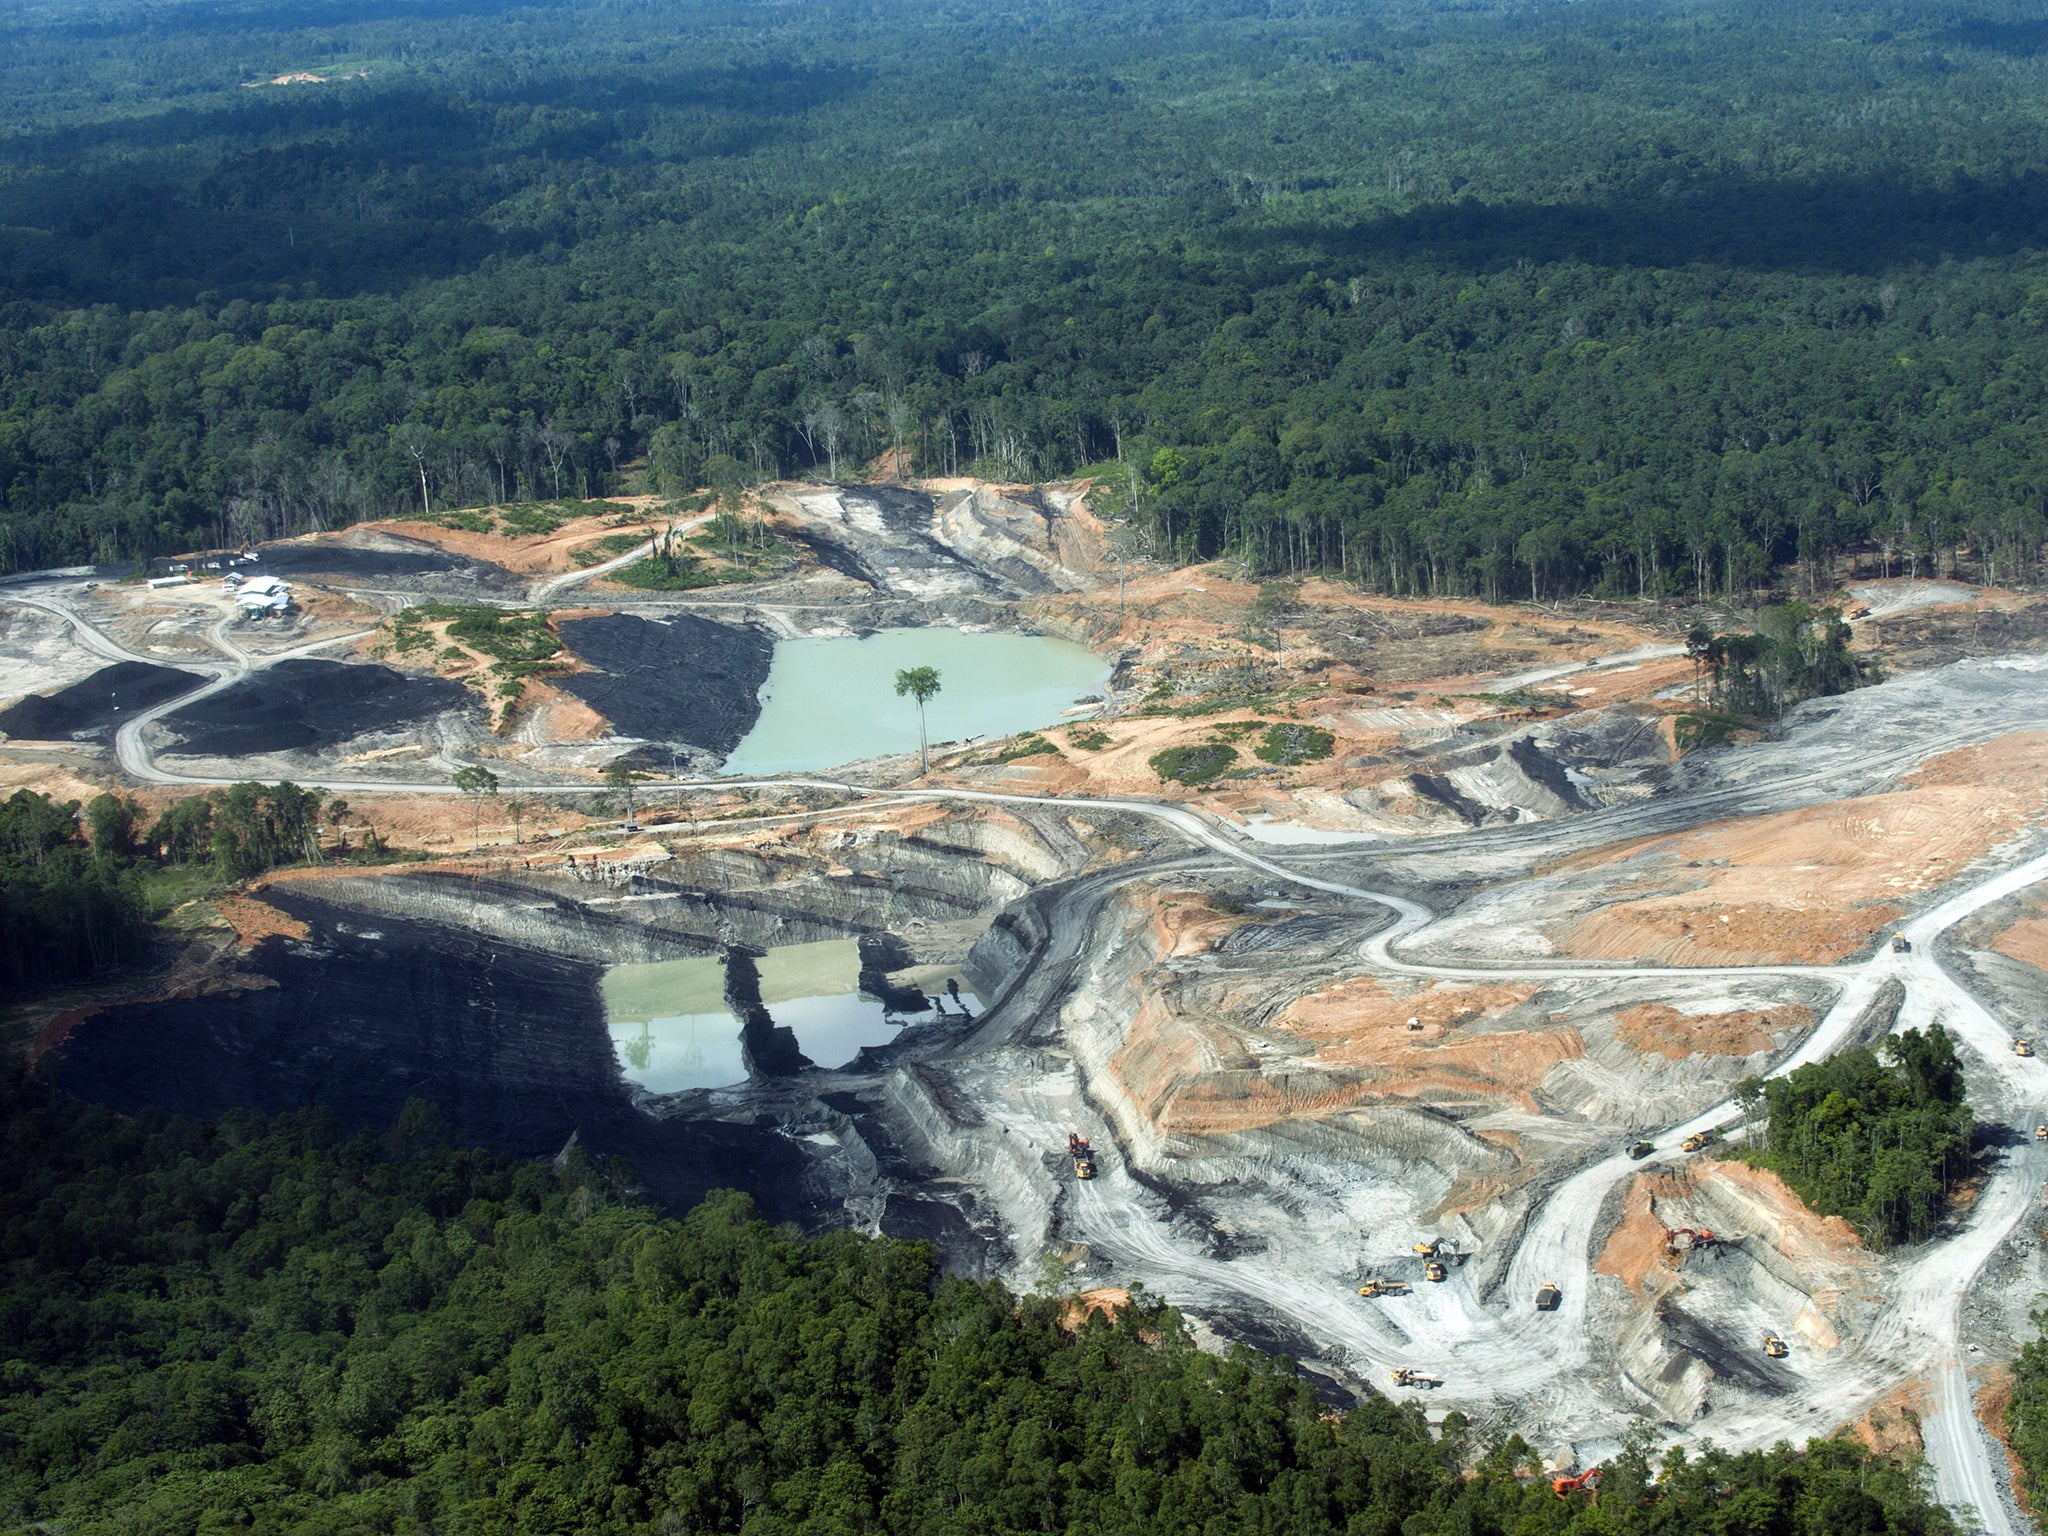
(8, 577), (2048, 1530)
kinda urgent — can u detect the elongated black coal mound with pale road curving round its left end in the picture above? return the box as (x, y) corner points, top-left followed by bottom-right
(162, 657), (475, 758)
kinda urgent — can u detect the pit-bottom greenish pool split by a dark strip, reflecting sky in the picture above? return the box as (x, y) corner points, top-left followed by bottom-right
(602, 938), (981, 1094)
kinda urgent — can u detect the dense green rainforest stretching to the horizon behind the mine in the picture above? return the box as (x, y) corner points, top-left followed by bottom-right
(0, 0), (2048, 598)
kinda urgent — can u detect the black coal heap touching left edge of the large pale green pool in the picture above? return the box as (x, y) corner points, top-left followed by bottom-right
(555, 614), (774, 754)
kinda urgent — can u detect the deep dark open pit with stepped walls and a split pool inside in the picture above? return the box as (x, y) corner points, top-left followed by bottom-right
(53, 807), (1105, 1274)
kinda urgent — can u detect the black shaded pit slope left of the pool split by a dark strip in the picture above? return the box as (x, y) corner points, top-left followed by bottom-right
(55, 891), (821, 1223)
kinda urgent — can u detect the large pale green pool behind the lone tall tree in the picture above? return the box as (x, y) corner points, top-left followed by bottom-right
(725, 629), (1110, 774)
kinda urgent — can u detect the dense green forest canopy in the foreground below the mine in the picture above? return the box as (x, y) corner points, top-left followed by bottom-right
(0, 1073), (1954, 1536)
